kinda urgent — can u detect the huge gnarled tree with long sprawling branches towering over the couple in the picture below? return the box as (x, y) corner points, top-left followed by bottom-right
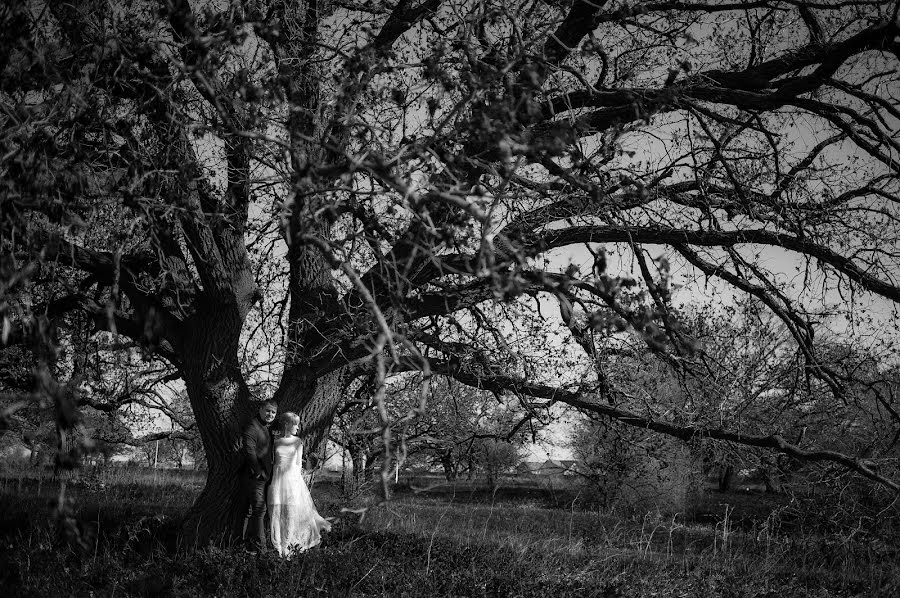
(0, 0), (900, 542)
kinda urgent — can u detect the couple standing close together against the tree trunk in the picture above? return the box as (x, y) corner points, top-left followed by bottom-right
(236, 400), (331, 556)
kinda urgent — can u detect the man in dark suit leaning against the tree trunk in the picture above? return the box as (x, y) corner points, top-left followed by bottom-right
(237, 399), (278, 551)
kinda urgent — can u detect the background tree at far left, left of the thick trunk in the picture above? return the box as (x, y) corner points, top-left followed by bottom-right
(0, 287), (183, 469)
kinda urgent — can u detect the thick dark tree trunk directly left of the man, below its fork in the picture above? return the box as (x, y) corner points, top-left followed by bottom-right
(182, 306), (253, 548)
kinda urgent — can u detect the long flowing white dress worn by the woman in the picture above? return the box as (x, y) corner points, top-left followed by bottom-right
(268, 436), (331, 556)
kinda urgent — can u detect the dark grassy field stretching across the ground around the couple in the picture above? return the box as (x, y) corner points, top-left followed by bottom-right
(0, 469), (900, 597)
